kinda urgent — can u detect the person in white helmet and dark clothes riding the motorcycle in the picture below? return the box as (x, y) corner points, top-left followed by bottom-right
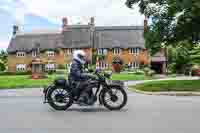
(69, 50), (95, 103)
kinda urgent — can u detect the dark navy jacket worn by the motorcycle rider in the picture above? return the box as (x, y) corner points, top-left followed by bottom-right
(69, 60), (89, 81)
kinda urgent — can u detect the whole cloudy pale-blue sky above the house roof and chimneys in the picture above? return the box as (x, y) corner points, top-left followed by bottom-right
(0, 0), (144, 49)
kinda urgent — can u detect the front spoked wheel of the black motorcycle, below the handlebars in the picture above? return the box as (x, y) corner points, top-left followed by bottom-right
(102, 86), (127, 110)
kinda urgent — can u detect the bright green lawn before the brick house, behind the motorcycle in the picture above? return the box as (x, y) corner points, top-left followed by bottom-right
(0, 74), (149, 89)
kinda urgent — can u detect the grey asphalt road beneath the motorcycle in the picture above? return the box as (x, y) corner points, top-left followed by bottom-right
(0, 93), (200, 133)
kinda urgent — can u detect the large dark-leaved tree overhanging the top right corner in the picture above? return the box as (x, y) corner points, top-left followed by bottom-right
(126, 0), (200, 53)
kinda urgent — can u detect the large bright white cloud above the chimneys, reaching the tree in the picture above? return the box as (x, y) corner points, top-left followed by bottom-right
(18, 0), (144, 25)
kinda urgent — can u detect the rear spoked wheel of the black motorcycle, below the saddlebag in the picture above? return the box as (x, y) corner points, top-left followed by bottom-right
(47, 87), (73, 110)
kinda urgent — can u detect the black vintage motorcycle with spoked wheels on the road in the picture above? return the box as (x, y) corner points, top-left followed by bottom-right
(43, 70), (127, 110)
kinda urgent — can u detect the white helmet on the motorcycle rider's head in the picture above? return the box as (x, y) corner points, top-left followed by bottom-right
(73, 50), (86, 64)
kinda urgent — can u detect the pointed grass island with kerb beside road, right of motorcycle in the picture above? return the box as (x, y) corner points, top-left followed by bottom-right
(130, 80), (200, 92)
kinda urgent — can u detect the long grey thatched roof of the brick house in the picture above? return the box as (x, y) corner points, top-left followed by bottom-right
(7, 25), (144, 53)
